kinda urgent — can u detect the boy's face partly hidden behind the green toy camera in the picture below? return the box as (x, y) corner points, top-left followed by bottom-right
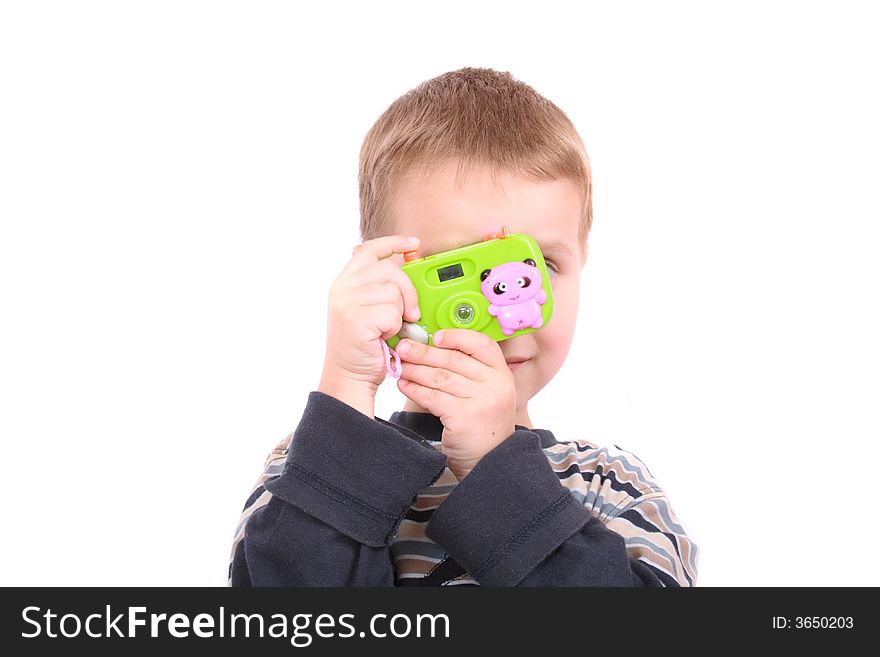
(391, 159), (586, 428)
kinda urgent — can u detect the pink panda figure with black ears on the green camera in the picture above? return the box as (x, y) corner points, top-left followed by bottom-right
(480, 258), (547, 335)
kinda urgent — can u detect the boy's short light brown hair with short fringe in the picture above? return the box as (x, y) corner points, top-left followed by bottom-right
(358, 68), (593, 247)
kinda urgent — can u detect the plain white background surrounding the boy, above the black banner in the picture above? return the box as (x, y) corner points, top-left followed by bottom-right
(0, 0), (880, 586)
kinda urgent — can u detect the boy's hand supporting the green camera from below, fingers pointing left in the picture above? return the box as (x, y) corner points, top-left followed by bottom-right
(396, 329), (516, 480)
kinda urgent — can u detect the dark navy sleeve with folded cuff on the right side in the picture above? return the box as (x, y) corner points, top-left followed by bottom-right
(425, 429), (696, 586)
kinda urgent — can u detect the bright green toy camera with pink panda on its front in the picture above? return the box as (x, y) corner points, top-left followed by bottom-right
(386, 226), (553, 349)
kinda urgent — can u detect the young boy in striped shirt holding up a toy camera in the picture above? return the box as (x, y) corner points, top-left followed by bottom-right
(229, 68), (697, 586)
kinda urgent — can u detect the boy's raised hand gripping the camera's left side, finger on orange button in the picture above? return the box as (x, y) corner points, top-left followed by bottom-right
(318, 235), (419, 417)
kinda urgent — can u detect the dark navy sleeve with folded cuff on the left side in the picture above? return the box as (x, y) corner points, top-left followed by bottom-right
(229, 391), (446, 586)
